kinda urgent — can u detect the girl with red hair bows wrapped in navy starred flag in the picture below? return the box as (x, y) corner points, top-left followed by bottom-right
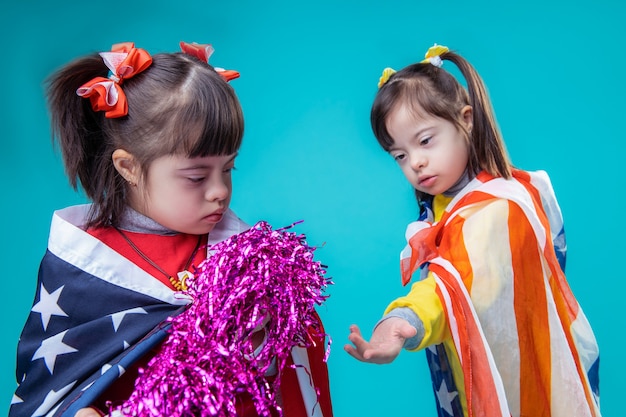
(9, 43), (332, 417)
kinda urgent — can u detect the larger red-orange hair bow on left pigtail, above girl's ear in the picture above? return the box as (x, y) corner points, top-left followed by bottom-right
(76, 42), (152, 119)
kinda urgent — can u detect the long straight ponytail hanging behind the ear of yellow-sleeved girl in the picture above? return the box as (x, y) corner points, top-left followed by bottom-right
(437, 52), (511, 178)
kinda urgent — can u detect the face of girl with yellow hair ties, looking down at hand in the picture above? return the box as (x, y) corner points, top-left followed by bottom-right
(386, 105), (472, 195)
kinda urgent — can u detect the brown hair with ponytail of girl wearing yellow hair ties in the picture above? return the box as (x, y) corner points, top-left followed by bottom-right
(370, 52), (511, 200)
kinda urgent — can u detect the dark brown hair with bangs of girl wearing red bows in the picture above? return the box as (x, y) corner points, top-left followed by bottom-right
(47, 53), (243, 227)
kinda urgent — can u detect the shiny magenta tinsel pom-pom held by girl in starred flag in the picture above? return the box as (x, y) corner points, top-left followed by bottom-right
(120, 222), (331, 417)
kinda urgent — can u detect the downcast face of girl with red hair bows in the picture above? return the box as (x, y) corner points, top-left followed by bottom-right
(131, 154), (237, 235)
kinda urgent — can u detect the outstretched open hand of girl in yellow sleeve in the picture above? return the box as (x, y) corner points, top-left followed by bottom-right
(344, 317), (417, 364)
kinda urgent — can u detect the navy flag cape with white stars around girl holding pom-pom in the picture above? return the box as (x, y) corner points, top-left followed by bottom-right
(9, 205), (332, 417)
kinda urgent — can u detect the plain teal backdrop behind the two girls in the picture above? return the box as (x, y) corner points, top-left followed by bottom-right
(0, 0), (626, 417)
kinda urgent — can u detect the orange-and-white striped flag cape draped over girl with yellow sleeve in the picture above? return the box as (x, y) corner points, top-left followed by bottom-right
(401, 170), (600, 417)
